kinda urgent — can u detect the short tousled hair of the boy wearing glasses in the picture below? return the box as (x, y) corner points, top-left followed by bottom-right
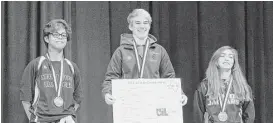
(43, 19), (72, 47)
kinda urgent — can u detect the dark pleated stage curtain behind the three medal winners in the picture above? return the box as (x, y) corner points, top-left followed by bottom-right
(1, 1), (273, 123)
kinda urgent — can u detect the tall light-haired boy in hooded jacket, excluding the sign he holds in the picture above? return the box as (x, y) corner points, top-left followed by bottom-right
(102, 9), (188, 105)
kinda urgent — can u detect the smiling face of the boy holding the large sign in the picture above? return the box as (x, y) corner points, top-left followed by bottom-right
(129, 15), (151, 39)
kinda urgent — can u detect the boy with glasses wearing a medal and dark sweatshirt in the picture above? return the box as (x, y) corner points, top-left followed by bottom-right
(20, 19), (83, 123)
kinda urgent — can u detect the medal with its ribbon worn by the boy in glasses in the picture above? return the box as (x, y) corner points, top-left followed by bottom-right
(46, 54), (64, 107)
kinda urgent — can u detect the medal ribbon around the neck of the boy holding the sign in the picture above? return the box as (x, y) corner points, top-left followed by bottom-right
(133, 40), (149, 78)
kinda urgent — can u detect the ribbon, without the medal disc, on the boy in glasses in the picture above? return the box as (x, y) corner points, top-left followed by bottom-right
(46, 54), (64, 97)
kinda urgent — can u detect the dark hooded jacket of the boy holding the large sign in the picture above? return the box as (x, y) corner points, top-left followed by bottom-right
(102, 34), (175, 95)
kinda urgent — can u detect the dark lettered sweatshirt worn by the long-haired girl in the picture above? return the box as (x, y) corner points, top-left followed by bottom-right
(193, 79), (255, 123)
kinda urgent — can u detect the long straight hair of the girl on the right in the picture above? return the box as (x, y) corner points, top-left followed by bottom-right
(206, 46), (252, 101)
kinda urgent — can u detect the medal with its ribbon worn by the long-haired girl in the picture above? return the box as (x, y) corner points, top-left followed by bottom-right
(218, 77), (233, 122)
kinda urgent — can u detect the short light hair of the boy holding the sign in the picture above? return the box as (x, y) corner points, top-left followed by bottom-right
(127, 9), (152, 24)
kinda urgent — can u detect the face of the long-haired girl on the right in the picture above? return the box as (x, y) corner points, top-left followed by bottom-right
(218, 49), (234, 69)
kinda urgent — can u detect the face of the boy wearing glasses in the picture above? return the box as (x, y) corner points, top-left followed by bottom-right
(45, 28), (68, 50)
